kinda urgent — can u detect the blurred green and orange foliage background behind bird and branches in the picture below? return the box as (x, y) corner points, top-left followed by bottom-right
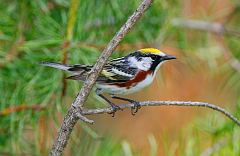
(0, 0), (240, 156)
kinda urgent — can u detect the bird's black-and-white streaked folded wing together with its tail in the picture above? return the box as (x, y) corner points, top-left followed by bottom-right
(41, 58), (137, 84)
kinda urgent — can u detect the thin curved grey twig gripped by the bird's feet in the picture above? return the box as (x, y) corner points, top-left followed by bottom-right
(82, 101), (240, 126)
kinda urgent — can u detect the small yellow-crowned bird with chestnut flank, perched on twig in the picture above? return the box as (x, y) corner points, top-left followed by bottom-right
(40, 48), (176, 116)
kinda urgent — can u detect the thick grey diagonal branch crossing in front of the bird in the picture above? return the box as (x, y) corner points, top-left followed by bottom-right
(50, 0), (152, 156)
